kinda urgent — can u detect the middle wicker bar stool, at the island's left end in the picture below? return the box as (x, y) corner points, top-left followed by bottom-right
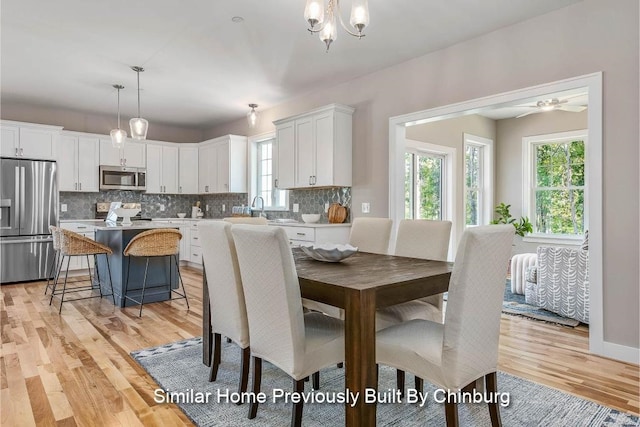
(49, 228), (116, 313)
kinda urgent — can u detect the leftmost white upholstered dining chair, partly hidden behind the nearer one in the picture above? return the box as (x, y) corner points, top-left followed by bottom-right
(198, 221), (251, 393)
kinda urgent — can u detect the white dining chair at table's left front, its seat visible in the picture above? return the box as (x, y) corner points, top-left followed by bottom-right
(231, 225), (344, 426)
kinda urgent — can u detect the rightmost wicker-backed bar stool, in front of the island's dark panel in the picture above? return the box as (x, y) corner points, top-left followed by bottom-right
(123, 228), (189, 317)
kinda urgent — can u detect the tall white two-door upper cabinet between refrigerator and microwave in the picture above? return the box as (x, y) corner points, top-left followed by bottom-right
(57, 132), (100, 192)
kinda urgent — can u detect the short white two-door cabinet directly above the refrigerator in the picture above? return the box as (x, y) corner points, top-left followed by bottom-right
(0, 120), (62, 160)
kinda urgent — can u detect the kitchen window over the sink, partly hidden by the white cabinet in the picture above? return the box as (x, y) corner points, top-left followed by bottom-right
(255, 138), (287, 210)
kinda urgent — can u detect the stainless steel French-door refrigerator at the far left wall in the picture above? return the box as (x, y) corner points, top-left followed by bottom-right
(0, 158), (58, 284)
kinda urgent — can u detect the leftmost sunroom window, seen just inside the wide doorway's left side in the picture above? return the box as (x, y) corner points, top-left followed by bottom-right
(404, 150), (445, 220)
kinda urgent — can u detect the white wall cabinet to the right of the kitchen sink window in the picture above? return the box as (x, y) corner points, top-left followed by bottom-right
(273, 104), (355, 188)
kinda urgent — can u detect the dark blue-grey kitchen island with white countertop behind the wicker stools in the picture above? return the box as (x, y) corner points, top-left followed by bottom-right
(94, 221), (179, 307)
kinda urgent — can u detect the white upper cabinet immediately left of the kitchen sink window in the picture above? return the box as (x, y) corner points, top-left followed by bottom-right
(198, 135), (247, 193)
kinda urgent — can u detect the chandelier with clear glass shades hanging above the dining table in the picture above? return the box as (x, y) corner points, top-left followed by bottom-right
(304, 0), (369, 52)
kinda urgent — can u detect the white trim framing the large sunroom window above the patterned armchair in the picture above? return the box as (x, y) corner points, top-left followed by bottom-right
(522, 129), (589, 245)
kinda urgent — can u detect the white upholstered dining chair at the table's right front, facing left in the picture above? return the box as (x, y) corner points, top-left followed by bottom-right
(376, 224), (515, 427)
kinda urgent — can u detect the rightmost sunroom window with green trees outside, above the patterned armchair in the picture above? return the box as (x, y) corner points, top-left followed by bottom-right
(523, 130), (587, 237)
